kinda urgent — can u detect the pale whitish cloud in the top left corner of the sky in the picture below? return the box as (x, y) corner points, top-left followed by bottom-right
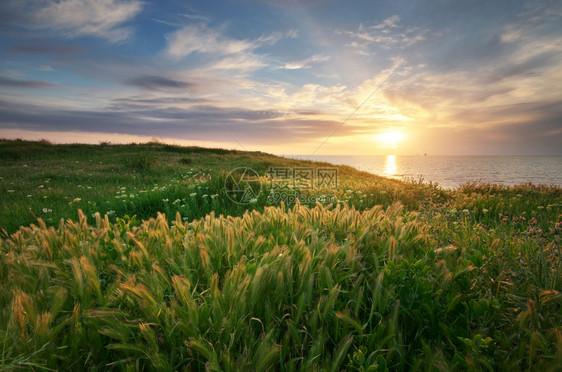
(0, 0), (142, 42)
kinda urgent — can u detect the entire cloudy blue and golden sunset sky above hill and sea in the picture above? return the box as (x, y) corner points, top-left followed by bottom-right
(0, 0), (562, 155)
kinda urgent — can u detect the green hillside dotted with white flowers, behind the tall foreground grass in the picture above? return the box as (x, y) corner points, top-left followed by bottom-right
(0, 140), (438, 233)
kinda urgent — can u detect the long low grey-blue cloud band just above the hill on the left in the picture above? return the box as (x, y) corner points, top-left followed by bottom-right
(0, 96), (364, 148)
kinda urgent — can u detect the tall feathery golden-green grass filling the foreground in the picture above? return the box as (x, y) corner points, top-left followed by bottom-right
(0, 203), (562, 371)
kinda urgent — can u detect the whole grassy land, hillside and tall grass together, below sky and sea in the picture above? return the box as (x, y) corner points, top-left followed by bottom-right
(0, 141), (562, 371)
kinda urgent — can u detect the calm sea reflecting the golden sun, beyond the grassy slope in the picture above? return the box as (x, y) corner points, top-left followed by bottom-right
(290, 155), (562, 189)
